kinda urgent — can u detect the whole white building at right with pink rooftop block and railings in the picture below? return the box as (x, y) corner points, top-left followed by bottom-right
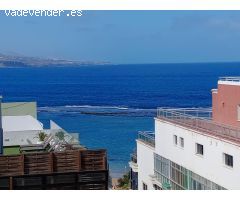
(130, 77), (240, 190)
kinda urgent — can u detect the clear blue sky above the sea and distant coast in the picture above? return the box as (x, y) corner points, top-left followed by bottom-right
(0, 11), (240, 64)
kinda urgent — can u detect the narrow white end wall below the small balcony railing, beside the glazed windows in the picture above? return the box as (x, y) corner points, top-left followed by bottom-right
(137, 140), (154, 190)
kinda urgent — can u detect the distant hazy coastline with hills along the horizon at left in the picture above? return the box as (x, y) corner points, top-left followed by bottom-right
(0, 54), (110, 68)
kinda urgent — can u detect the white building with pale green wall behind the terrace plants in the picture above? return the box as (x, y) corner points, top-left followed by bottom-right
(2, 102), (79, 147)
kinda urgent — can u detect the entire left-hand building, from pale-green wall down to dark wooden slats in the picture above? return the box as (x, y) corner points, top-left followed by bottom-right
(0, 98), (109, 190)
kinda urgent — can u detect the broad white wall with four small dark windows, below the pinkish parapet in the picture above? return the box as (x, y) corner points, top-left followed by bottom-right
(155, 119), (240, 189)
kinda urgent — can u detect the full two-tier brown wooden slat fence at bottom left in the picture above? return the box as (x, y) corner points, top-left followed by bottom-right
(0, 150), (108, 189)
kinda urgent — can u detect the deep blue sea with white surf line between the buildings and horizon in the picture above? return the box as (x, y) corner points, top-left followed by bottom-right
(0, 63), (240, 177)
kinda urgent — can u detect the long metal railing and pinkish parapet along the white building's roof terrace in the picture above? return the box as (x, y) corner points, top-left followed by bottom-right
(157, 108), (240, 143)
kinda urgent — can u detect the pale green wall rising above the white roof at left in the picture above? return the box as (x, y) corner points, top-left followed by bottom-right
(2, 102), (37, 118)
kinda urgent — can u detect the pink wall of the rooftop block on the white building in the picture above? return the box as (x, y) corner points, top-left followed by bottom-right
(212, 83), (240, 127)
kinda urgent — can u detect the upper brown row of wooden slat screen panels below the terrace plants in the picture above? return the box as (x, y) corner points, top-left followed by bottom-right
(0, 150), (108, 177)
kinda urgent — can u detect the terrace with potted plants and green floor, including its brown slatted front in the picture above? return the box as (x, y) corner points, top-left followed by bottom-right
(0, 130), (108, 190)
